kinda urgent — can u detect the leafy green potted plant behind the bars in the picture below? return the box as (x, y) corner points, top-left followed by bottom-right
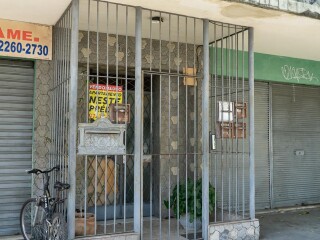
(164, 179), (215, 222)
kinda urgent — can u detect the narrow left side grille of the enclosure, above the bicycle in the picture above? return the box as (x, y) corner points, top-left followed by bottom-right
(48, 2), (72, 213)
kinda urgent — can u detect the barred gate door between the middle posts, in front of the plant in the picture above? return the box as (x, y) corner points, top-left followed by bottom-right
(143, 71), (202, 239)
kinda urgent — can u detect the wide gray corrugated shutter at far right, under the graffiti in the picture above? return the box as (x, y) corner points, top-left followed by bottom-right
(272, 85), (320, 207)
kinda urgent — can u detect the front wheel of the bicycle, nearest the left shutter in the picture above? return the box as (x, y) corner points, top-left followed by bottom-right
(20, 198), (47, 240)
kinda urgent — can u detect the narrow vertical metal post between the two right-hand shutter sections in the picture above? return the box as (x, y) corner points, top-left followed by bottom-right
(268, 83), (274, 208)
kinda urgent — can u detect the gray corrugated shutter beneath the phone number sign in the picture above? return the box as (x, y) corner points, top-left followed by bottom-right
(0, 60), (34, 235)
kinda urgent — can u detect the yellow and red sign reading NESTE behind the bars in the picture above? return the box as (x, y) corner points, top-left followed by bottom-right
(89, 83), (123, 120)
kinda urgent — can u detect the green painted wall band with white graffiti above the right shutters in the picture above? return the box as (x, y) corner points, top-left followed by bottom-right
(210, 47), (320, 86)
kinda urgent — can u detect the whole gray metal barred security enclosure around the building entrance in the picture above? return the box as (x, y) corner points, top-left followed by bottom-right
(53, 0), (254, 239)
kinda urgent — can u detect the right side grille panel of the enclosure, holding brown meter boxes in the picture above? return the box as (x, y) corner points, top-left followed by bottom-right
(210, 23), (250, 221)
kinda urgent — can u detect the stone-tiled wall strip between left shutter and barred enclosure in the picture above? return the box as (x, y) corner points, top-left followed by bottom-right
(33, 60), (53, 194)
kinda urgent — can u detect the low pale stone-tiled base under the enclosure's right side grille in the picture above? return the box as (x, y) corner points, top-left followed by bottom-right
(208, 219), (260, 240)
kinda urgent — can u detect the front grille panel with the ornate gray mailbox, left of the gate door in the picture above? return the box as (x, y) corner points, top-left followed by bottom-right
(76, 0), (135, 236)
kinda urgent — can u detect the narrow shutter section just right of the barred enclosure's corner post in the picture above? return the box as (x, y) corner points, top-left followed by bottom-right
(254, 82), (270, 209)
